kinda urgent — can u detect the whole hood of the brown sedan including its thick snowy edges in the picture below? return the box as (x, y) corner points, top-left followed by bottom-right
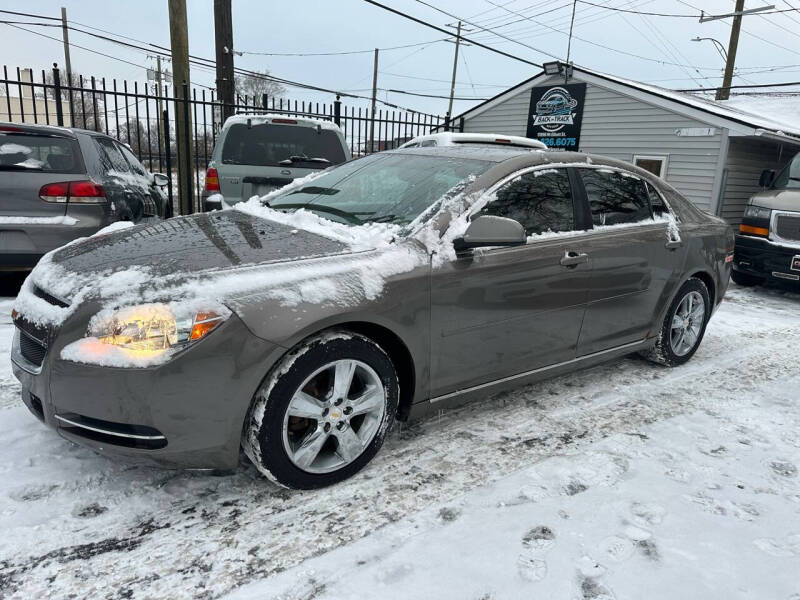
(14, 208), (428, 327)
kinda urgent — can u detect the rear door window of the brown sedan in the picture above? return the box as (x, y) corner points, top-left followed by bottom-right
(578, 169), (652, 226)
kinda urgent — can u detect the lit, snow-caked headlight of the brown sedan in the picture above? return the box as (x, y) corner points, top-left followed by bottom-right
(61, 304), (230, 367)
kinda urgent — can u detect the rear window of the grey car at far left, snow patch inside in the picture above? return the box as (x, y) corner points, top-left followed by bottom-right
(0, 133), (83, 173)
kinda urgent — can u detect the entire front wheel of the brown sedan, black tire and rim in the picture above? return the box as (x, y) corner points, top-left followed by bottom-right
(242, 331), (399, 489)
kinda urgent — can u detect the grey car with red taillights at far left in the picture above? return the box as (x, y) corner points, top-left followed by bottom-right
(0, 123), (169, 271)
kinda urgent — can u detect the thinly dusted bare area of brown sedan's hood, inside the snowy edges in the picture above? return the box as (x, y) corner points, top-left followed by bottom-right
(52, 210), (348, 276)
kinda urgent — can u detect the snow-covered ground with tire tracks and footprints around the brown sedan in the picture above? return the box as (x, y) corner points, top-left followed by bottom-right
(0, 278), (800, 600)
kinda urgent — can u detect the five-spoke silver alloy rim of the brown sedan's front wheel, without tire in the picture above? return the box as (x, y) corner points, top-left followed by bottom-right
(283, 359), (386, 473)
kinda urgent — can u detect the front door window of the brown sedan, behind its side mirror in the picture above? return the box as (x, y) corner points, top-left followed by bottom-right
(480, 169), (575, 236)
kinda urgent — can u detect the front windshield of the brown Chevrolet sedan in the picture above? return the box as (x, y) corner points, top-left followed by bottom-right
(269, 154), (493, 225)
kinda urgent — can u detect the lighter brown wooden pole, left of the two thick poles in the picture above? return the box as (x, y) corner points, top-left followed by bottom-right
(167, 0), (194, 215)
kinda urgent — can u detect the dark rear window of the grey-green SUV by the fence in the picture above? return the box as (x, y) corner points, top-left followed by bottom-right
(222, 123), (345, 168)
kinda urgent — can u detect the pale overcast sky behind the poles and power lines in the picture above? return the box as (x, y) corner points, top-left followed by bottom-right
(0, 0), (800, 114)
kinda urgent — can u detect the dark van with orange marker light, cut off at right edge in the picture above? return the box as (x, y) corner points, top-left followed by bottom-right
(731, 154), (800, 286)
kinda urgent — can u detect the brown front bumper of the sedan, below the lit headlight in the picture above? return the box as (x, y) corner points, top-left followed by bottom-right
(11, 315), (283, 469)
